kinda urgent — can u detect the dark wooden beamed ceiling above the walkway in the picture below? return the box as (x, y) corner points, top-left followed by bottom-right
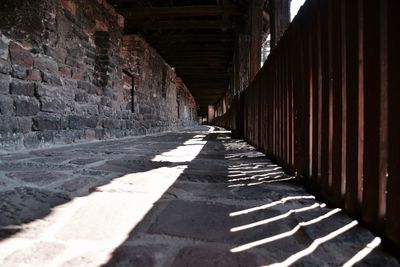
(108, 0), (248, 107)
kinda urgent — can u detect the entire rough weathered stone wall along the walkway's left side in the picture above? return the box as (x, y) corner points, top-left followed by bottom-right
(0, 0), (196, 151)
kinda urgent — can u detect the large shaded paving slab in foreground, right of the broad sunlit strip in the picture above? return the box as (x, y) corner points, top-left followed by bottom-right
(148, 200), (297, 244)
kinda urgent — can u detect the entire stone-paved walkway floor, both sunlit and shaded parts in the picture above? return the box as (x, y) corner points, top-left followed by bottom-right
(0, 126), (400, 267)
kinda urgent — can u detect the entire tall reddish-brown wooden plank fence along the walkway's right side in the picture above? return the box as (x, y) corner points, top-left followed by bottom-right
(215, 0), (400, 251)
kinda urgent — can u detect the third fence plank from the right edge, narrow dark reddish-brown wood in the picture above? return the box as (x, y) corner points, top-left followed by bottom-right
(345, 0), (363, 216)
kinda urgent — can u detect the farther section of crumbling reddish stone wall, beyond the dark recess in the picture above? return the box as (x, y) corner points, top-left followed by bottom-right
(121, 35), (196, 129)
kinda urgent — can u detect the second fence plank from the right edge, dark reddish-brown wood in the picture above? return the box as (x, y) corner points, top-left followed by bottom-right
(362, 0), (387, 229)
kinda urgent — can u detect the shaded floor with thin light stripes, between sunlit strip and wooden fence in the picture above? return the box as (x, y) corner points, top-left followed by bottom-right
(104, 129), (399, 267)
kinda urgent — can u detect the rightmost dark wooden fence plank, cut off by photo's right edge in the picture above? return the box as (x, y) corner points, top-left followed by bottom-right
(385, 1), (400, 251)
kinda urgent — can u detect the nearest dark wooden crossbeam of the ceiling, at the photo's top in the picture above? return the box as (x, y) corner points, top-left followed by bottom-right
(117, 5), (244, 20)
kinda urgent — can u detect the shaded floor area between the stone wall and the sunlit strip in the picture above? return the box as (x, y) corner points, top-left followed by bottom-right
(0, 129), (208, 242)
